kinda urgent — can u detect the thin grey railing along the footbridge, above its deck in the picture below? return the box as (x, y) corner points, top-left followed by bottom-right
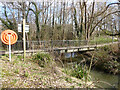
(5, 40), (117, 51)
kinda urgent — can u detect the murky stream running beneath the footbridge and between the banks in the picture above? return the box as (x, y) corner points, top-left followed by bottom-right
(63, 53), (119, 88)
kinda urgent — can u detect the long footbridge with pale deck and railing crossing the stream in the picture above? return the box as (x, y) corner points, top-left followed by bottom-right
(0, 40), (118, 54)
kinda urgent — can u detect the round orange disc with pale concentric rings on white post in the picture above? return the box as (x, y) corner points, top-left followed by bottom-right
(1, 29), (18, 45)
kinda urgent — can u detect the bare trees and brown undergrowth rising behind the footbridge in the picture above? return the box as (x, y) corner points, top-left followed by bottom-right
(0, 0), (120, 41)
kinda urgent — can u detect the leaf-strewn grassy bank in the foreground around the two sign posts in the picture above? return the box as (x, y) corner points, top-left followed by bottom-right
(0, 53), (94, 88)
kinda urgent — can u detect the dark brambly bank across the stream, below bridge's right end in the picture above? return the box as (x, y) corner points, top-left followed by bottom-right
(86, 44), (120, 74)
